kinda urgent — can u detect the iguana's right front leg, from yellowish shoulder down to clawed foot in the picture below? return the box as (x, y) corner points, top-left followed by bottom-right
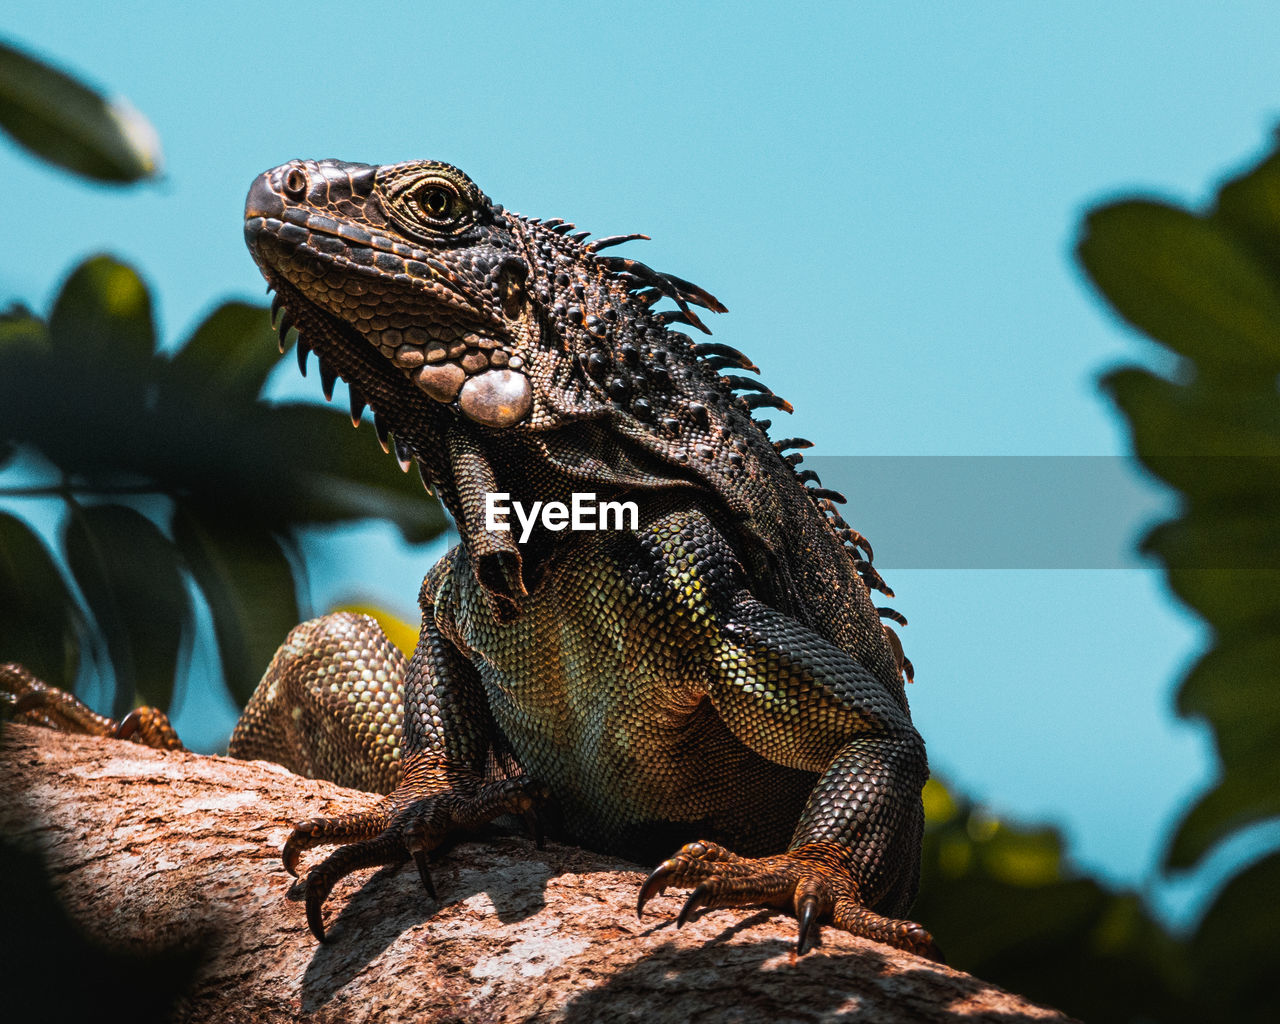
(637, 527), (941, 959)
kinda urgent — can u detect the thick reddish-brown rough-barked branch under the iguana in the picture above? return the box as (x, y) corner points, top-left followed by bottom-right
(0, 726), (1068, 1024)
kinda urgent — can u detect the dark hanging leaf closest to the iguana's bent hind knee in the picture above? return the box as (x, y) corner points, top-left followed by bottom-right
(173, 504), (298, 705)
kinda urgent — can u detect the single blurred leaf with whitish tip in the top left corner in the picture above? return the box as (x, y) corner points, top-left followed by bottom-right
(0, 42), (161, 182)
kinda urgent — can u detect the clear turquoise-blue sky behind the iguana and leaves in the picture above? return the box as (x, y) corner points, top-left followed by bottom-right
(0, 0), (1280, 926)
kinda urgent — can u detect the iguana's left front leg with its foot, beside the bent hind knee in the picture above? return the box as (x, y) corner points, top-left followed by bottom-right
(271, 599), (545, 941)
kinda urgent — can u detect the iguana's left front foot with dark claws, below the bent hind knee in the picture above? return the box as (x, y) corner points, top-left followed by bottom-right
(282, 776), (548, 942)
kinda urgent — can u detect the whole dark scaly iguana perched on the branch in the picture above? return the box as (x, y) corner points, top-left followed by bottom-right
(5, 160), (940, 959)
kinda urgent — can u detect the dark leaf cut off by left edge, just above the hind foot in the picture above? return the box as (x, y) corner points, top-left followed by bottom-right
(0, 512), (82, 689)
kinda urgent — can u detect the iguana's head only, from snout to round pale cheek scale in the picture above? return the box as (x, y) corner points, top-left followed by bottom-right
(244, 160), (549, 428)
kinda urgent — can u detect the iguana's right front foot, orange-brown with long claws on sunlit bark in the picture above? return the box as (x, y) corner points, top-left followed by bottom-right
(636, 842), (943, 963)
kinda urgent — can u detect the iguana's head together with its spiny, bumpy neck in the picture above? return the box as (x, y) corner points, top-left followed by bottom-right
(244, 160), (747, 436)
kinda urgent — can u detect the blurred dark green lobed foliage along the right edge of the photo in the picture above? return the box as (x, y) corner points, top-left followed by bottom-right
(1079, 138), (1280, 1020)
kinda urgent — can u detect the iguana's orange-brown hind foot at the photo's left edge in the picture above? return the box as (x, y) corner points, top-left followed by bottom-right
(0, 662), (183, 750)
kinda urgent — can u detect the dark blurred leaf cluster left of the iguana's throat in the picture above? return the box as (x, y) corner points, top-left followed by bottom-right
(0, 256), (444, 716)
